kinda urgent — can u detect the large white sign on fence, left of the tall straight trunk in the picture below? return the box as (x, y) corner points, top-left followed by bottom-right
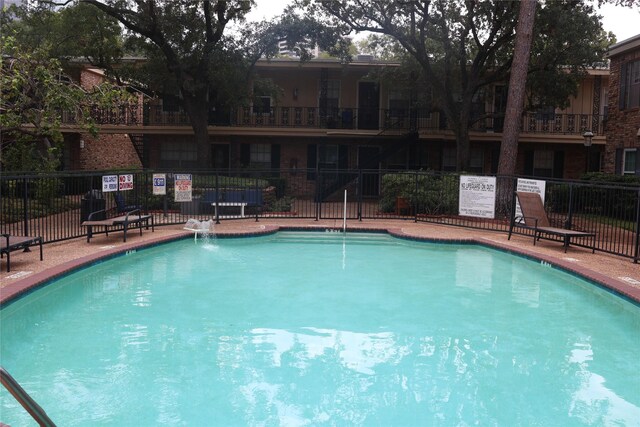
(458, 175), (496, 218)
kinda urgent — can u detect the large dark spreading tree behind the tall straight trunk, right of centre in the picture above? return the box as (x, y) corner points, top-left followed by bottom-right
(306, 0), (606, 170)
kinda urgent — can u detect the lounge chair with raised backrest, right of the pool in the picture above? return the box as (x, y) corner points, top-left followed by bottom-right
(508, 191), (596, 252)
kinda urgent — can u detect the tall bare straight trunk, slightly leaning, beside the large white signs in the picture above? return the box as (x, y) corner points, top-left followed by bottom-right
(498, 0), (537, 175)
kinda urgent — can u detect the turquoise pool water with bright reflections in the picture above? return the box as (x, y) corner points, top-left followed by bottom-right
(0, 232), (640, 427)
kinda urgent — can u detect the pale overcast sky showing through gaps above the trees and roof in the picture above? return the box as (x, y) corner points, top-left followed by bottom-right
(250, 0), (640, 42)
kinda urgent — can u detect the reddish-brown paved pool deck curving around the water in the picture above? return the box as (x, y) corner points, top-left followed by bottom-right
(0, 219), (640, 304)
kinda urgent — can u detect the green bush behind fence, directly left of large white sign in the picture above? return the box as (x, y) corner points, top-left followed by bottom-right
(379, 172), (459, 215)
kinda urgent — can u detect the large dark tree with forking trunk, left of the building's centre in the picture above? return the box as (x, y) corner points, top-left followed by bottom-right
(64, 0), (348, 168)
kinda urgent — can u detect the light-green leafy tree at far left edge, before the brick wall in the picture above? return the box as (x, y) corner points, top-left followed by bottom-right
(0, 35), (130, 171)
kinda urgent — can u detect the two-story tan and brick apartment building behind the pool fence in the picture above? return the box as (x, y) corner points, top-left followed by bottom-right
(65, 56), (611, 186)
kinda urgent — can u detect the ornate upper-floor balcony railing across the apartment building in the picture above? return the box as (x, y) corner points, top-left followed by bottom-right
(57, 104), (606, 135)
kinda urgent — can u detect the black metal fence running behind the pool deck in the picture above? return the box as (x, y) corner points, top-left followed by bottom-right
(0, 169), (640, 262)
